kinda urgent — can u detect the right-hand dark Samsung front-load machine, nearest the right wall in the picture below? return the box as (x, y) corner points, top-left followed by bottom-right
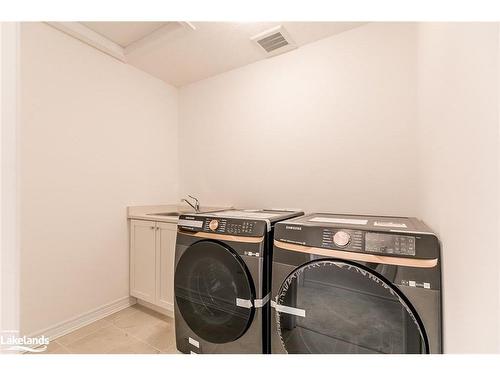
(271, 213), (442, 354)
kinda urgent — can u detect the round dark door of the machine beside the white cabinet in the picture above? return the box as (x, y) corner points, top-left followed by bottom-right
(174, 241), (255, 344)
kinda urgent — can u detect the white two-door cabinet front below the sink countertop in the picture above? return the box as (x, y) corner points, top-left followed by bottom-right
(130, 220), (177, 311)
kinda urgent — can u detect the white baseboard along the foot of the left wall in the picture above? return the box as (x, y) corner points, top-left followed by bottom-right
(26, 296), (137, 341)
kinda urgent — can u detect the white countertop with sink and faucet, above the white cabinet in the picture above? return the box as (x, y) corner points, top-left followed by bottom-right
(127, 204), (228, 223)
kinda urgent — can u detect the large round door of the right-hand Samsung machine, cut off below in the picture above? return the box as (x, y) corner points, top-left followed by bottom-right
(273, 259), (428, 353)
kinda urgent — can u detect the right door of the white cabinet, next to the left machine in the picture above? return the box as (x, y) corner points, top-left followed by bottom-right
(156, 223), (177, 311)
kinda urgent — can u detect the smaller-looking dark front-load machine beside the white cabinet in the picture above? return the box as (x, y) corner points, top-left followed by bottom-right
(174, 209), (303, 353)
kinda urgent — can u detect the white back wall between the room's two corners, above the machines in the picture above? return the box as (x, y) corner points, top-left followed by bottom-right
(179, 24), (416, 215)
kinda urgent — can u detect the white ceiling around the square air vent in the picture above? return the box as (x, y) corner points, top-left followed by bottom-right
(66, 22), (364, 86)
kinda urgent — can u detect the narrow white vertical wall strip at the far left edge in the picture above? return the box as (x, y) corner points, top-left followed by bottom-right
(0, 22), (20, 346)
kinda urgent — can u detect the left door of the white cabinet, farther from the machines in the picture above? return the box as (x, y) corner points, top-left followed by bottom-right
(130, 220), (156, 303)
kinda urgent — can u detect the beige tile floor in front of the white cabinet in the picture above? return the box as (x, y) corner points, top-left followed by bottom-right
(35, 304), (179, 354)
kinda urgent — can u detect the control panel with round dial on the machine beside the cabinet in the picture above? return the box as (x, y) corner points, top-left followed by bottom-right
(177, 215), (267, 236)
